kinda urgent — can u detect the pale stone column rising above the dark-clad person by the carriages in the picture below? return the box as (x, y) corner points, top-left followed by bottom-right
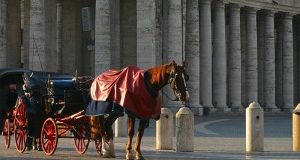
(29, 0), (46, 70)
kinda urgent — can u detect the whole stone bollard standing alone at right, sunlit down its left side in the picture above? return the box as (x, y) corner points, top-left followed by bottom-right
(246, 102), (264, 152)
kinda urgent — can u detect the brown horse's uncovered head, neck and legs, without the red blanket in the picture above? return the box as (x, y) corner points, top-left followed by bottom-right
(90, 61), (188, 159)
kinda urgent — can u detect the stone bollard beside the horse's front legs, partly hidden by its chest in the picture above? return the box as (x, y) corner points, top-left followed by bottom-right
(156, 108), (174, 150)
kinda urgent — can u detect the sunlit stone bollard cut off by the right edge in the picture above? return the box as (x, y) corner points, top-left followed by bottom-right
(292, 103), (300, 152)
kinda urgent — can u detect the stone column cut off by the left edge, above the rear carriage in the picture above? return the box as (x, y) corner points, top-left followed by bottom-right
(0, 0), (7, 68)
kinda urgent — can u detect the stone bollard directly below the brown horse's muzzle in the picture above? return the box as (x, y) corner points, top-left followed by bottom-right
(176, 107), (194, 152)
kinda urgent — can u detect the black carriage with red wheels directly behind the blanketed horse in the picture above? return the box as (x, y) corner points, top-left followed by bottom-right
(40, 74), (95, 155)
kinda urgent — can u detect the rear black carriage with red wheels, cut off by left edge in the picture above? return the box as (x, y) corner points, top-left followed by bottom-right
(0, 69), (29, 153)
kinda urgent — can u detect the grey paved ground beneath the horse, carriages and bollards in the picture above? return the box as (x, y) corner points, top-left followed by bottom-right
(0, 114), (300, 160)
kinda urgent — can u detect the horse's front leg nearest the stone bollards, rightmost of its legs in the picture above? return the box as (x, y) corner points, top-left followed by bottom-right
(135, 120), (148, 160)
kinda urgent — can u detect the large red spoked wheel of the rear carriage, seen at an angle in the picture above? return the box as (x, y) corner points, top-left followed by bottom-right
(14, 99), (27, 153)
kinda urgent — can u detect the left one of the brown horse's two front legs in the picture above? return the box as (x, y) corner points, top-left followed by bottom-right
(126, 115), (135, 160)
